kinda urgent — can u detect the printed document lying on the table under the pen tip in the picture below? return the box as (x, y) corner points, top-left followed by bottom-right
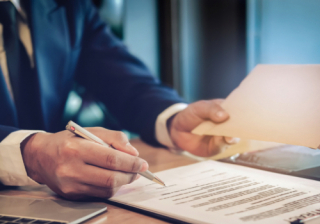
(110, 161), (320, 224)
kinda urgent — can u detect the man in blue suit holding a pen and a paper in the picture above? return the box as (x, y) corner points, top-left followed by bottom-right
(0, 0), (238, 199)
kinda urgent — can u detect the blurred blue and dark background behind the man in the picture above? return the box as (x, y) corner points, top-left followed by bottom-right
(64, 0), (320, 136)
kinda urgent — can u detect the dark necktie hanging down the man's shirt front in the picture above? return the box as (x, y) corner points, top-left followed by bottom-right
(0, 1), (44, 129)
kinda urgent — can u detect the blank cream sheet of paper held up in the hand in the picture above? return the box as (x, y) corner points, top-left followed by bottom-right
(193, 65), (320, 148)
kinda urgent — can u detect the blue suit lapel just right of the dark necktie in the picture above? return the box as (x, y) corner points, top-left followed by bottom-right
(29, 0), (70, 129)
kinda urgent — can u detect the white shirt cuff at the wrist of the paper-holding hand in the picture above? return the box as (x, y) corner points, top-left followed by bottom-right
(156, 103), (188, 152)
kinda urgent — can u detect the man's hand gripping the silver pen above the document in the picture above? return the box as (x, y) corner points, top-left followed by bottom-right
(21, 128), (148, 200)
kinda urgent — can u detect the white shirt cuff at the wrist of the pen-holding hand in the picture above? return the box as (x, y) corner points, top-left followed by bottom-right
(0, 130), (44, 186)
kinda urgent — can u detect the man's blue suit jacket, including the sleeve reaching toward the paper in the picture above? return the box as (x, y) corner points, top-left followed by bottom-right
(0, 0), (181, 144)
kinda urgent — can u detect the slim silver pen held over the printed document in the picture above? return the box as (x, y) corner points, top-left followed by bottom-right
(66, 121), (166, 186)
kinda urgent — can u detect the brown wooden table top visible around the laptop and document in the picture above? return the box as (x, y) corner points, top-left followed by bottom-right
(0, 139), (275, 224)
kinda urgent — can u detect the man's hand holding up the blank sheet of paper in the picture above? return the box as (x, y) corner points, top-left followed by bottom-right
(168, 99), (239, 156)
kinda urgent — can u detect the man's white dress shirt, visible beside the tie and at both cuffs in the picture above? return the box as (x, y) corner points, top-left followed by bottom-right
(0, 0), (187, 186)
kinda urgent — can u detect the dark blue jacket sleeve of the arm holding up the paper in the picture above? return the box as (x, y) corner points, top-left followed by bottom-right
(76, 1), (183, 145)
